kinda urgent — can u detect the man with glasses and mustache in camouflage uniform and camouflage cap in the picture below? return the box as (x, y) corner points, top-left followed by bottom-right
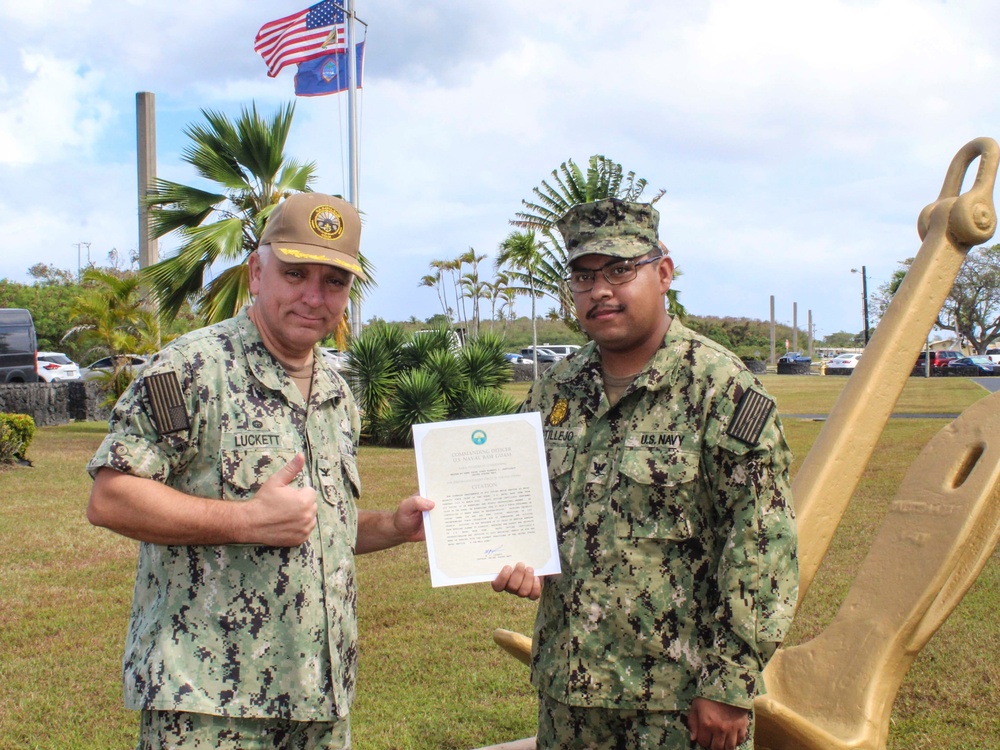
(493, 200), (798, 750)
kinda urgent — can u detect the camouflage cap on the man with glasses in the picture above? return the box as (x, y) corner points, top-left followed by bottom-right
(556, 198), (660, 263)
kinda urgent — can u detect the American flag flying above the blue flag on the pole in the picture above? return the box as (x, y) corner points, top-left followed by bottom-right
(253, 0), (347, 78)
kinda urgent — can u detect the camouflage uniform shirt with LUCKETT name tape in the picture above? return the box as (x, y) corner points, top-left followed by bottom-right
(88, 310), (360, 721)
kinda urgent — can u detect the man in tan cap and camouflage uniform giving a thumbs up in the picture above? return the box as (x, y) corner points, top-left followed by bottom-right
(87, 193), (433, 748)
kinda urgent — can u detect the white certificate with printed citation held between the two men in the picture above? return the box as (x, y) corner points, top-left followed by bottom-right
(413, 413), (559, 587)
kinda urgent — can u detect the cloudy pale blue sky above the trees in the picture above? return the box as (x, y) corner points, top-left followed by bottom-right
(0, 0), (1000, 337)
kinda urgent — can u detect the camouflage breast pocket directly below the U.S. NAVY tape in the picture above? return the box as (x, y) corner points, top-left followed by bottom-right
(615, 448), (701, 541)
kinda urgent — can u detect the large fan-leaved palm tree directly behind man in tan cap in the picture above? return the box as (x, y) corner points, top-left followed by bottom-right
(143, 104), (372, 323)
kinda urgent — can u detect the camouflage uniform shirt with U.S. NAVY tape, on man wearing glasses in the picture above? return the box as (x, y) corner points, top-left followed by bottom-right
(523, 320), (798, 710)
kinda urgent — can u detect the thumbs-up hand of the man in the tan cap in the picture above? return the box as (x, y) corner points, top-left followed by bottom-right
(241, 453), (316, 547)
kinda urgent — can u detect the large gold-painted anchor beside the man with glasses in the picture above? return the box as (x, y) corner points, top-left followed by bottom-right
(493, 138), (1000, 750)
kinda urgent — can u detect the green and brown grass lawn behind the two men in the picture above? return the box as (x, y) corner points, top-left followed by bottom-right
(0, 376), (1000, 750)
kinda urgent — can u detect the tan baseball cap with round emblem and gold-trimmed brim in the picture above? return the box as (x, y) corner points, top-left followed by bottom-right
(260, 193), (367, 280)
